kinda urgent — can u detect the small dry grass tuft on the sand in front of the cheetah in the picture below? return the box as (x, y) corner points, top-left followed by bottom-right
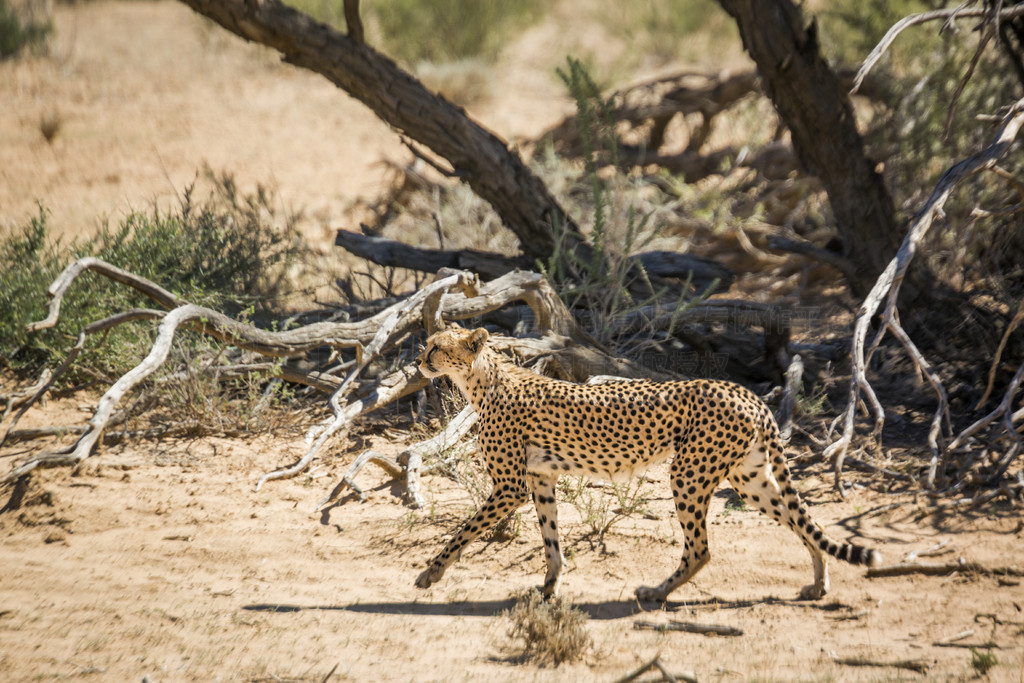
(508, 591), (592, 667)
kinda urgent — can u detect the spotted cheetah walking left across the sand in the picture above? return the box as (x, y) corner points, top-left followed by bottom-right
(416, 327), (881, 601)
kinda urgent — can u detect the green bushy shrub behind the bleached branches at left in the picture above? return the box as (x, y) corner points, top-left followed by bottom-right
(0, 178), (300, 381)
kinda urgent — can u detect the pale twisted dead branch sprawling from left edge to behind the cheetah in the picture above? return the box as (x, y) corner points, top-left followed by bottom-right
(0, 257), (671, 493)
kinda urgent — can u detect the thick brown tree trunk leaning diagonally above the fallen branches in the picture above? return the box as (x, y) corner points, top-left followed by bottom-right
(175, 0), (589, 259)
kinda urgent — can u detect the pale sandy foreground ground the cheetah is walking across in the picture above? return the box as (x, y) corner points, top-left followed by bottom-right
(0, 411), (1024, 681)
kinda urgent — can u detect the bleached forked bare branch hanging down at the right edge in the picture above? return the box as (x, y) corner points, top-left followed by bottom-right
(824, 98), (1024, 494)
